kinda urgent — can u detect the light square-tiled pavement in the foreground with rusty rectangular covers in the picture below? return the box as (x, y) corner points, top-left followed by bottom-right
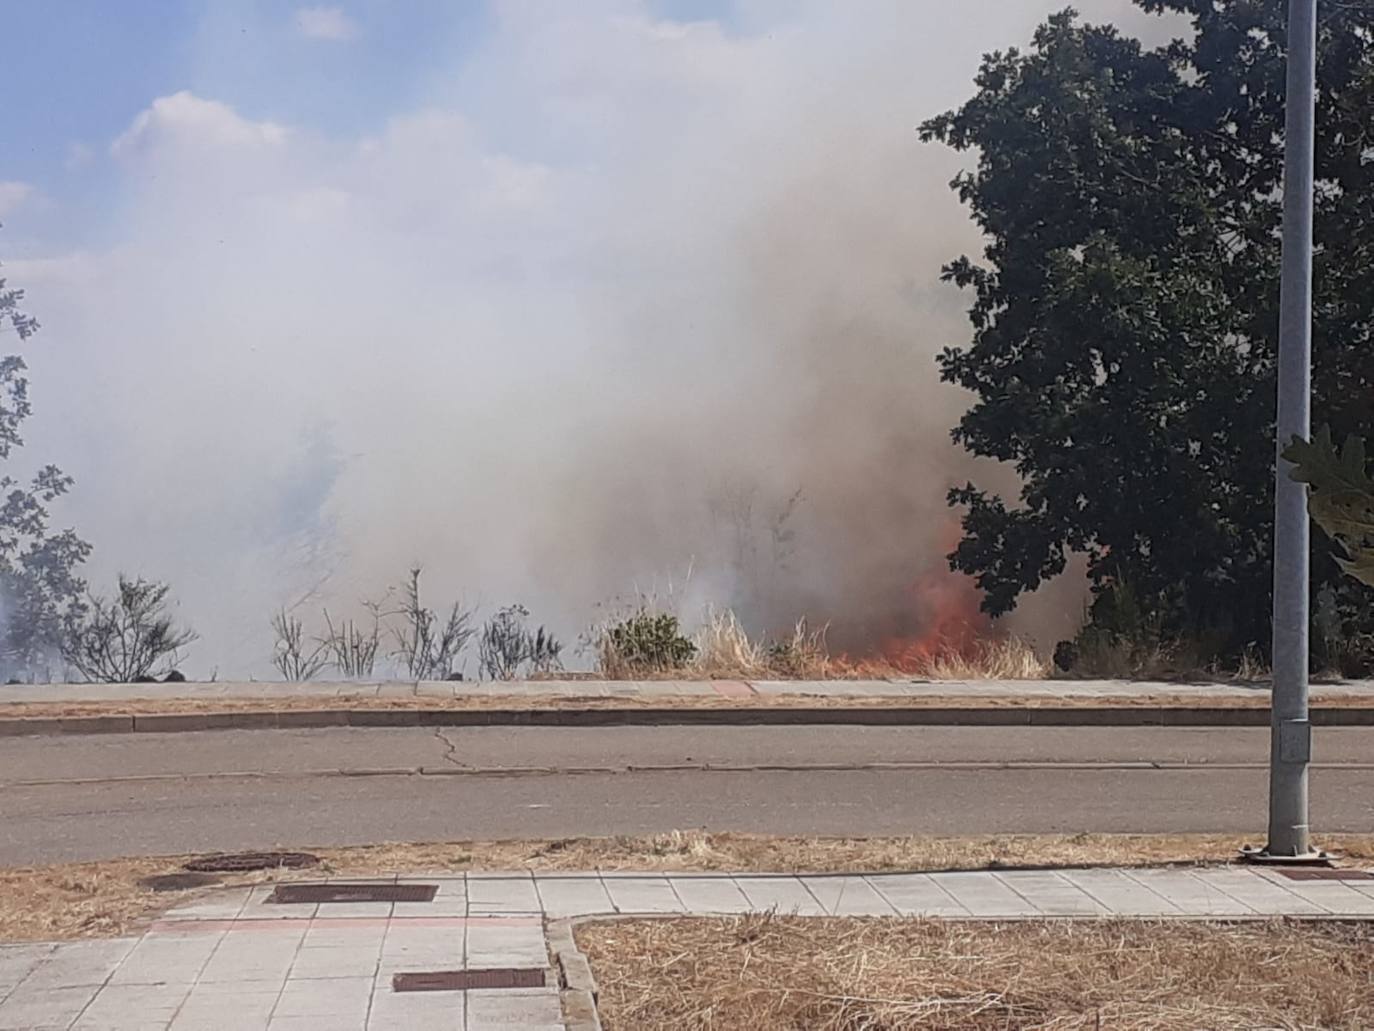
(0, 866), (1374, 1031)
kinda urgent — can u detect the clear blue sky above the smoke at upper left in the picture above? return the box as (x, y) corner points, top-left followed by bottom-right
(0, 0), (734, 253)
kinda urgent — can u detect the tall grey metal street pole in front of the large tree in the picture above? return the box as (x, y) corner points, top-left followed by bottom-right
(1264, 0), (1316, 861)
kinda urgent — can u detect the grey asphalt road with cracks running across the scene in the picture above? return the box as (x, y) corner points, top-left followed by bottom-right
(0, 727), (1374, 865)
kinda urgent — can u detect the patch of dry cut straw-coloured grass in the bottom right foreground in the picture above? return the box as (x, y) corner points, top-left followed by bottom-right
(576, 914), (1374, 1031)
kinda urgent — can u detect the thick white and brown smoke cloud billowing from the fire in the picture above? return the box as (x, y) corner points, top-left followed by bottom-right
(7, 0), (1145, 675)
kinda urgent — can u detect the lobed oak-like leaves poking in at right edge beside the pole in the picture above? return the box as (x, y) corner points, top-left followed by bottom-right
(1283, 426), (1374, 587)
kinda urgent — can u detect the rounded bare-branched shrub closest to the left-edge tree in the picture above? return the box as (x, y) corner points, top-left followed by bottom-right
(63, 573), (198, 683)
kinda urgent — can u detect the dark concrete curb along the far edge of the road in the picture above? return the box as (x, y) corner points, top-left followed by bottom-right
(0, 704), (1374, 737)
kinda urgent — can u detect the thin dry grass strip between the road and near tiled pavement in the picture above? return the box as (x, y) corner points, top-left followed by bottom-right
(10, 830), (1374, 942)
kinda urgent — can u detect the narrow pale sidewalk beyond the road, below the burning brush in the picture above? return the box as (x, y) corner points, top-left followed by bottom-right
(0, 679), (1374, 712)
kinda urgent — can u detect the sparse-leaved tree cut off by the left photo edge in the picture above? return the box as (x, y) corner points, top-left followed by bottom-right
(0, 248), (91, 679)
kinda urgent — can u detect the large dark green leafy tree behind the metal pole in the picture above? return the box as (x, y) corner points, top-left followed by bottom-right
(922, 0), (1374, 653)
